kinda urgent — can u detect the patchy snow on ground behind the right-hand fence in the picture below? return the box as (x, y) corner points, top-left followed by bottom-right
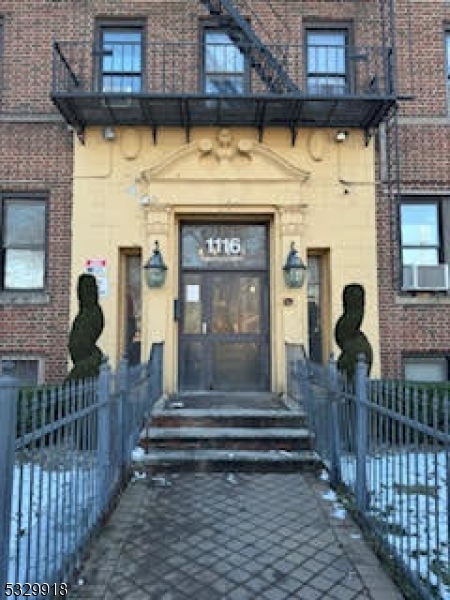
(342, 450), (450, 600)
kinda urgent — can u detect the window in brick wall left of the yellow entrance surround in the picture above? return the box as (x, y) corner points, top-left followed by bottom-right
(0, 195), (47, 291)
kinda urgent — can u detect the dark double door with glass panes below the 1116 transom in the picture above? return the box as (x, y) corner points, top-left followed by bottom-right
(179, 271), (270, 391)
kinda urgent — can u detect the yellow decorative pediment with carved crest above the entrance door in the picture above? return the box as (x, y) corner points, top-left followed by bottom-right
(140, 129), (310, 183)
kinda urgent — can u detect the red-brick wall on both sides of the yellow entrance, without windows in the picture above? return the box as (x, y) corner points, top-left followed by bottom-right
(0, 0), (450, 380)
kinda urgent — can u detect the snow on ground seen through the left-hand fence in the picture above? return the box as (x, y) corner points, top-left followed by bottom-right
(8, 462), (99, 584)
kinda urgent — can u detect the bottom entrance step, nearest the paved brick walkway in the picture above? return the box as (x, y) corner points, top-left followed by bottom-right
(133, 449), (323, 473)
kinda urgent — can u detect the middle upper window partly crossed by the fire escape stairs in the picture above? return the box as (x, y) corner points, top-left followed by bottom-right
(204, 29), (247, 94)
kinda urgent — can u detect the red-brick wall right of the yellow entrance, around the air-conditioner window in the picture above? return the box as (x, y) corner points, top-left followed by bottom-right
(377, 0), (450, 377)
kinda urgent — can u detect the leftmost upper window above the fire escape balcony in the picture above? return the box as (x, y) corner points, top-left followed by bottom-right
(99, 25), (143, 93)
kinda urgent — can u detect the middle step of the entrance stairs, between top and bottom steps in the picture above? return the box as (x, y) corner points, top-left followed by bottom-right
(141, 427), (312, 439)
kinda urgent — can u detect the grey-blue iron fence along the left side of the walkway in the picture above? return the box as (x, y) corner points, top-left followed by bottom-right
(0, 344), (162, 597)
